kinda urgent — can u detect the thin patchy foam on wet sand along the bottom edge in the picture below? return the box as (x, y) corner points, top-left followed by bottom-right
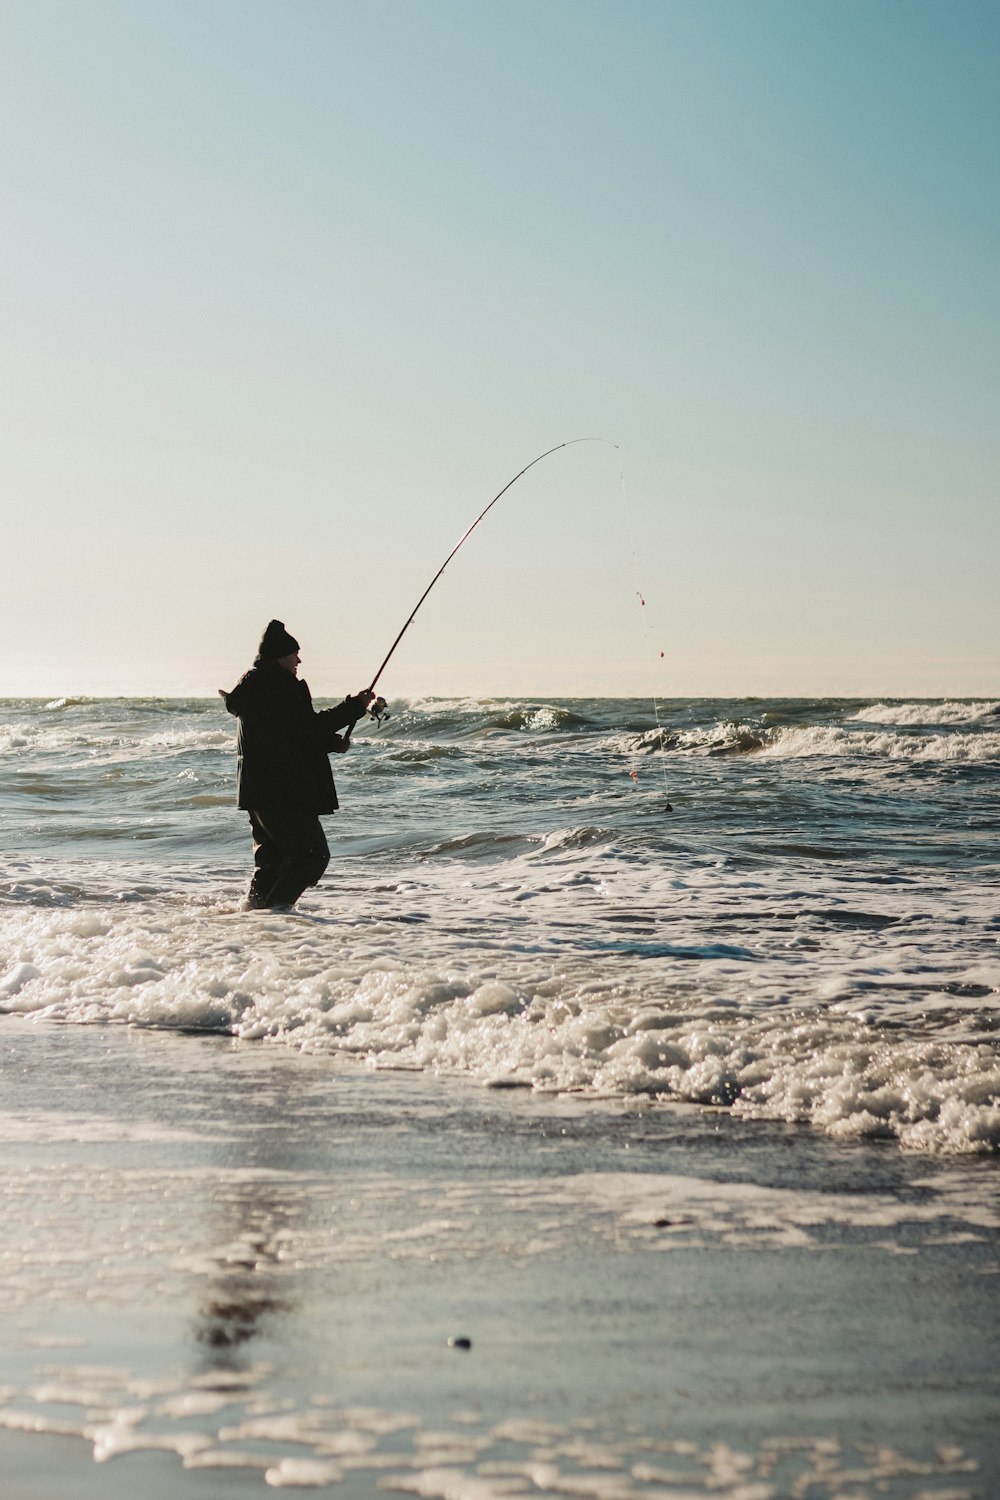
(0, 1362), (984, 1500)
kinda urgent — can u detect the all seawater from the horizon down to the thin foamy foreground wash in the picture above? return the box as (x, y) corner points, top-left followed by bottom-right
(0, 699), (1000, 1500)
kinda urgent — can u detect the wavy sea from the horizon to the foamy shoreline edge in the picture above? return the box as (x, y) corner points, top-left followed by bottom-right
(0, 699), (1000, 1155)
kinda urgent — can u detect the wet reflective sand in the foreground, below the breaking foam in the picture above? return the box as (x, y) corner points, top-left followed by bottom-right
(0, 1020), (1000, 1500)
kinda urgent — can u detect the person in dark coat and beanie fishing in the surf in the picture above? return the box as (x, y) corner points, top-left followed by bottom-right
(219, 620), (375, 911)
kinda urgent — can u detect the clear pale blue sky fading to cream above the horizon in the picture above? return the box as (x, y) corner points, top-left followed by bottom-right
(0, 0), (1000, 699)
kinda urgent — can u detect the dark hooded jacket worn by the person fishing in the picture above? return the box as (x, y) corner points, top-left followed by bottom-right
(225, 657), (364, 813)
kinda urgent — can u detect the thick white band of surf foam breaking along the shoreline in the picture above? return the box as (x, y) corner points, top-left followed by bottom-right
(0, 884), (1000, 1154)
